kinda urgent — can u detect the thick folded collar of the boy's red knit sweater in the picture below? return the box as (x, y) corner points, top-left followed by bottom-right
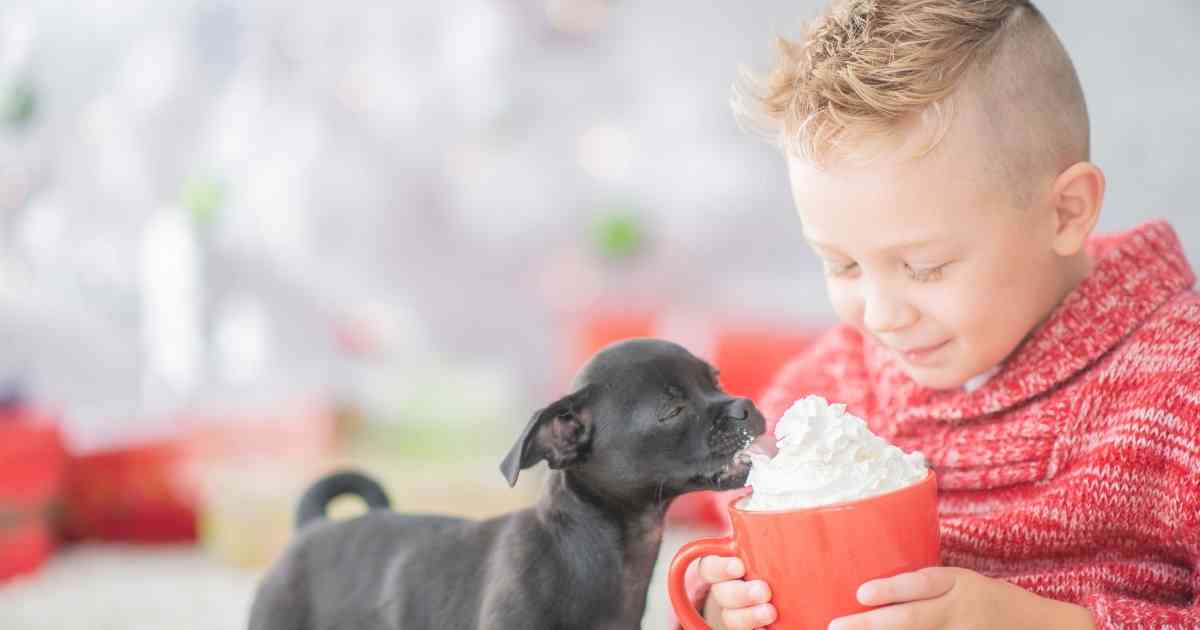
(865, 221), (1195, 424)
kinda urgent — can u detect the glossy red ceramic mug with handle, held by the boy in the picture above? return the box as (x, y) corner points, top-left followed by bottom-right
(667, 470), (941, 630)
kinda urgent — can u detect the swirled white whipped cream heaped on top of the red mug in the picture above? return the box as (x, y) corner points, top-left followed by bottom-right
(740, 396), (928, 510)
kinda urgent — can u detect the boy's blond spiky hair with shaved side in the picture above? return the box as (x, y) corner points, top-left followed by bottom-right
(733, 0), (1088, 188)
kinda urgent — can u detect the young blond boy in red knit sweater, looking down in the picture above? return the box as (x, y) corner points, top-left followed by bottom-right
(690, 0), (1200, 630)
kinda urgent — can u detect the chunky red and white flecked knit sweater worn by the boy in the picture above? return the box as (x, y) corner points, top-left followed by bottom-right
(734, 222), (1200, 629)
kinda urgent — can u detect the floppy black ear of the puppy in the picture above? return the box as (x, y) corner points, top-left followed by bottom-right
(500, 385), (595, 486)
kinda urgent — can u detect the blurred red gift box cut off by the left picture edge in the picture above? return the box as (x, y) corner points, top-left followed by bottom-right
(0, 408), (66, 580)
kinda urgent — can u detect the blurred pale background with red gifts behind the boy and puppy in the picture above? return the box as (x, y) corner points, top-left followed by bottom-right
(0, 0), (1200, 629)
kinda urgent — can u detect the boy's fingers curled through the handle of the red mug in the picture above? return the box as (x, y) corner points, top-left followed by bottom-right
(697, 556), (775, 630)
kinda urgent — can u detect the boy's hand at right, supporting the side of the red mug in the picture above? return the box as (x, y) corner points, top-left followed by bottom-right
(825, 566), (1094, 630)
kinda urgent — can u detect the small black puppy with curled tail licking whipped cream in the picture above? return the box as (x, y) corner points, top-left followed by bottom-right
(250, 340), (764, 630)
